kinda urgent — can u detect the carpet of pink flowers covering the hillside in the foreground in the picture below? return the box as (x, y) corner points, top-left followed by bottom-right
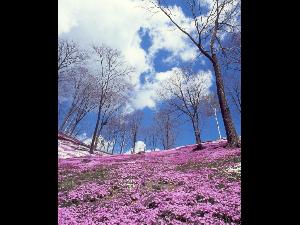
(58, 141), (241, 225)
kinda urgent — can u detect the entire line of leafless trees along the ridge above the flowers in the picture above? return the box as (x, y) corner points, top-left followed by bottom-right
(58, 0), (241, 153)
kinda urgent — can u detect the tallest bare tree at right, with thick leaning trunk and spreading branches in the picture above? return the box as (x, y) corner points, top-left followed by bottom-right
(144, 0), (240, 147)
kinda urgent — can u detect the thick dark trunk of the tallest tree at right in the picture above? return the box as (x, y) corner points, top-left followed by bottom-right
(212, 54), (240, 147)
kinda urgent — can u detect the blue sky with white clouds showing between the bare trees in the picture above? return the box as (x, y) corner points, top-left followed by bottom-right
(58, 0), (240, 151)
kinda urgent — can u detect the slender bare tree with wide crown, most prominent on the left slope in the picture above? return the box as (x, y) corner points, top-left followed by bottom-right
(90, 45), (133, 153)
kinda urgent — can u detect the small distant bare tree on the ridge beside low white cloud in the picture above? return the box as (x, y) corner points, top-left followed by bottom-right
(128, 110), (144, 153)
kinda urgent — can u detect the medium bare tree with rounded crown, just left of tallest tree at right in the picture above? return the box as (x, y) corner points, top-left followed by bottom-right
(161, 68), (210, 150)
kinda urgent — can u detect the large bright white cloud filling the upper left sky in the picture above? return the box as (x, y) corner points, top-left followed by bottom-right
(58, 0), (209, 109)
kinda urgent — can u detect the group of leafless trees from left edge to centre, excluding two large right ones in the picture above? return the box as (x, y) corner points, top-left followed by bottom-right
(58, 39), (180, 153)
